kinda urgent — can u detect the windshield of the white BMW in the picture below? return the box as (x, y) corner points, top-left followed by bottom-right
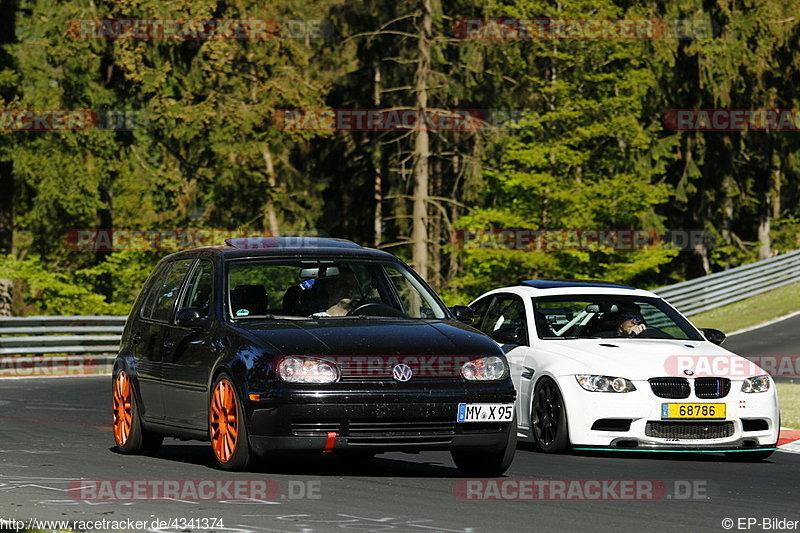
(533, 295), (703, 341)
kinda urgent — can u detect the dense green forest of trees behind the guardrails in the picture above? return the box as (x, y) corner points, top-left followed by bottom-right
(0, 0), (800, 314)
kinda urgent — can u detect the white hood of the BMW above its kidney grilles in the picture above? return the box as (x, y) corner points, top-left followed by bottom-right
(535, 338), (757, 381)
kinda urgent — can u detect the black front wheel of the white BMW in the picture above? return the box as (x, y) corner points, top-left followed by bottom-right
(531, 378), (570, 453)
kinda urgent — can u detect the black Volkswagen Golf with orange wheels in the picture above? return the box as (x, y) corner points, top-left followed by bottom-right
(113, 237), (516, 475)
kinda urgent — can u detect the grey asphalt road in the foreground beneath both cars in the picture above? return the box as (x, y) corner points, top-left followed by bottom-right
(0, 377), (800, 533)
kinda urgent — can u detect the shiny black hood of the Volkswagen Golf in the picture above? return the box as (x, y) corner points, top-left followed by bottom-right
(239, 318), (500, 355)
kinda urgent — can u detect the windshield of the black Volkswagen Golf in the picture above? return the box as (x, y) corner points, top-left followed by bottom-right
(228, 259), (447, 320)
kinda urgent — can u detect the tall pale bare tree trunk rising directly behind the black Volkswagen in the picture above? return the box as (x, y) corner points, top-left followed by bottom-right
(411, 0), (433, 279)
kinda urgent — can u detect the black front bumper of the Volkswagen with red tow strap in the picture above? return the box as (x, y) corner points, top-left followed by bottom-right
(248, 382), (515, 455)
